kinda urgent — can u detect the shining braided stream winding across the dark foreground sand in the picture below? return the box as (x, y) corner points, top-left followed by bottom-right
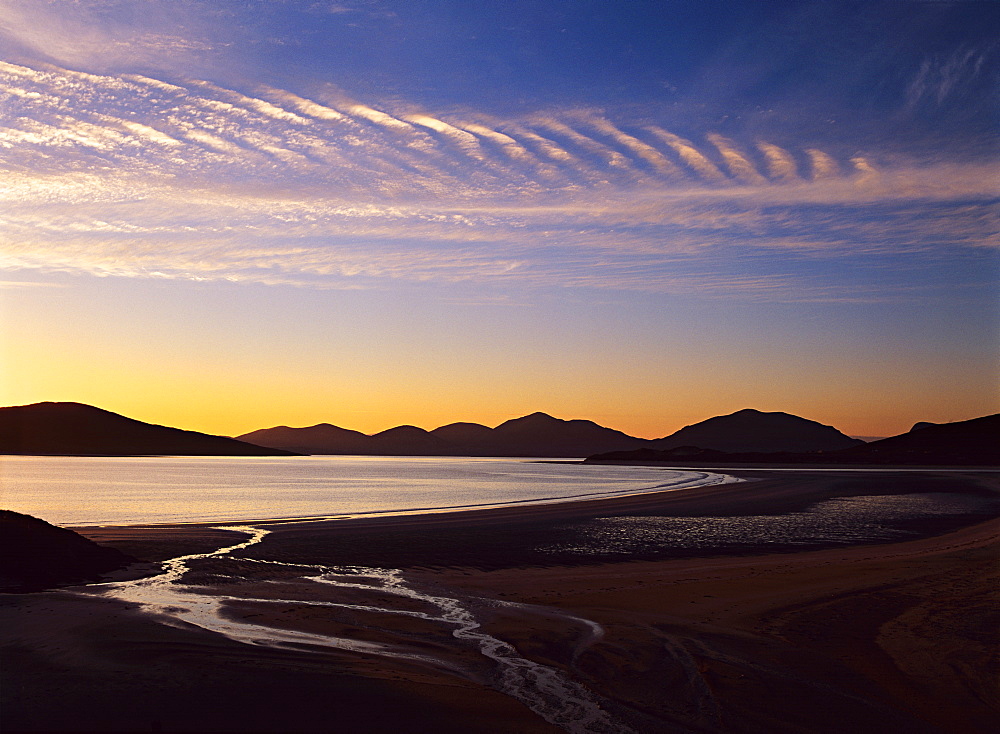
(89, 525), (630, 734)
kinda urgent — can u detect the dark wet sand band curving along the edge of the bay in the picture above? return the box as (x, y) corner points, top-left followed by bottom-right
(72, 469), (1000, 569)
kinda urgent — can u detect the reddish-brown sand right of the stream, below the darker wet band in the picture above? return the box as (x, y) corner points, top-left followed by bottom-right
(415, 518), (1000, 734)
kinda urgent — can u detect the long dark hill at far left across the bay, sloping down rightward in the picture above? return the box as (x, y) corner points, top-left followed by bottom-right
(0, 403), (289, 456)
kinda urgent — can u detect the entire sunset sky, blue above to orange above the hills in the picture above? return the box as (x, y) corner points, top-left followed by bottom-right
(0, 0), (1000, 438)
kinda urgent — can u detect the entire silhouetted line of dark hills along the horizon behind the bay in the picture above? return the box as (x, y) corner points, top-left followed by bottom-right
(0, 403), (984, 465)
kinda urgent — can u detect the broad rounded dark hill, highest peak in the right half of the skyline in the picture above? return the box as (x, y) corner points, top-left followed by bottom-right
(650, 408), (863, 453)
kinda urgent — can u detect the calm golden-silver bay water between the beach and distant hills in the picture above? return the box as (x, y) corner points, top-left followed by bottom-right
(0, 456), (733, 525)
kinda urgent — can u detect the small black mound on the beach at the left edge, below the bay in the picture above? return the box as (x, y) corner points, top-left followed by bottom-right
(0, 510), (136, 592)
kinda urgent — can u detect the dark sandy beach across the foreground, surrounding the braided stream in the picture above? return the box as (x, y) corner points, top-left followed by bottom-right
(0, 471), (1000, 732)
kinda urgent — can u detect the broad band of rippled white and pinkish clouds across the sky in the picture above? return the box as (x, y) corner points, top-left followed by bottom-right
(0, 63), (998, 300)
